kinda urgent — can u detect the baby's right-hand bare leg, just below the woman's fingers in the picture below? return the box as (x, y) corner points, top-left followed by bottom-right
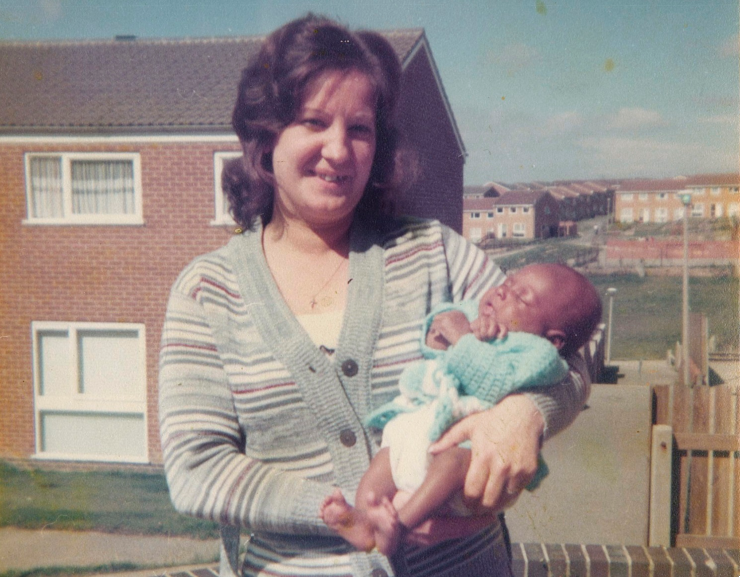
(398, 447), (470, 529)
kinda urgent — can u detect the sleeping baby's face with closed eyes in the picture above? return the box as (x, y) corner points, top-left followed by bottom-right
(478, 265), (558, 336)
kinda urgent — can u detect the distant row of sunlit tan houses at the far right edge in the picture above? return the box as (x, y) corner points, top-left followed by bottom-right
(614, 174), (740, 223)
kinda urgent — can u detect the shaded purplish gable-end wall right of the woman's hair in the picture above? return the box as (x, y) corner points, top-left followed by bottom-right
(398, 44), (465, 232)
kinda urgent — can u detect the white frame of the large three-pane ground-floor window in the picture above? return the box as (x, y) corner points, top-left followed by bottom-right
(31, 321), (150, 463)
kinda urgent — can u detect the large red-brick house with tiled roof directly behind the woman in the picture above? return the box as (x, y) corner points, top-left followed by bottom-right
(0, 30), (465, 463)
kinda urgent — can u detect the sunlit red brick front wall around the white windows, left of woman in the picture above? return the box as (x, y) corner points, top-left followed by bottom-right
(0, 143), (238, 462)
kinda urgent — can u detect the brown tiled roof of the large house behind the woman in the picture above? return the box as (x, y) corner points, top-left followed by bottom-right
(0, 29), (424, 134)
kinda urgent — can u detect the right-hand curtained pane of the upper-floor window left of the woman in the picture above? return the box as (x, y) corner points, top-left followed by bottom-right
(71, 160), (134, 214)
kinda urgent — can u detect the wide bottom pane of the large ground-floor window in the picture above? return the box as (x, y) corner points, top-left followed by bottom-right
(41, 412), (146, 460)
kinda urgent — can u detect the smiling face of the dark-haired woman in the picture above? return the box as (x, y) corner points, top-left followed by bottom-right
(272, 70), (376, 226)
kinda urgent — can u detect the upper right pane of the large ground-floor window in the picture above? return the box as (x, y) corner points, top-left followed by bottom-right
(77, 330), (144, 398)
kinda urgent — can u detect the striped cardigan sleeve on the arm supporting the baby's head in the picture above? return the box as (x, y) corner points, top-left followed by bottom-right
(443, 223), (591, 439)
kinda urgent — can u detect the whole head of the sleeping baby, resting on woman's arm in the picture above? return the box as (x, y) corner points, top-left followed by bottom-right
(478, 264), (601, 356)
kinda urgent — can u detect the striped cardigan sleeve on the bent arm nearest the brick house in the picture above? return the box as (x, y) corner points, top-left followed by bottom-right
(159, 285), (332, 535)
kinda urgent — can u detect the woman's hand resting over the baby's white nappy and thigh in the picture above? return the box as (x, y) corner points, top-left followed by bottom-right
(430, 394), (545, 513)
